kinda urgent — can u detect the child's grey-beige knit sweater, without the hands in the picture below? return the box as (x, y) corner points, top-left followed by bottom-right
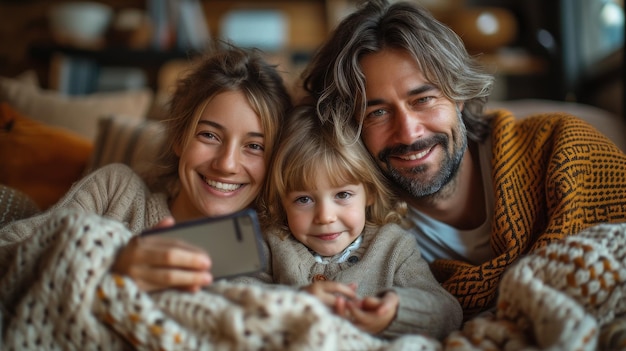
(233, 224), (463, 339)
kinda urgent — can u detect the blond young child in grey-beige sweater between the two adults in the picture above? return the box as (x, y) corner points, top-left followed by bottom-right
(233, 106), (462, 338)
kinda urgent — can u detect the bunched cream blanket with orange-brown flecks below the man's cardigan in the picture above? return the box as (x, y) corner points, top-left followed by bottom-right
(445, 223), (626, 351)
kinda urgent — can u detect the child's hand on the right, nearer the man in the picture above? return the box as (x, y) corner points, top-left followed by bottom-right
(346, 291), (400, 334)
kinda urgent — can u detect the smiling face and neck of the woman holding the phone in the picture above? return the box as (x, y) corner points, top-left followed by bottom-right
(171, 91), (266, 220)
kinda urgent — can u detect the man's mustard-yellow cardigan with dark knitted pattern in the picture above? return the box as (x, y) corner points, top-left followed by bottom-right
(432, 110), (626, 317)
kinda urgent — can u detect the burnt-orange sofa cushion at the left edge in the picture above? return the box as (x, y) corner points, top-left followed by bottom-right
(0, 103), (93, 210)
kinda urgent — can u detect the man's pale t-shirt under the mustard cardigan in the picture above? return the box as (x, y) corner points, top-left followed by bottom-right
(407, 140), (495, 264)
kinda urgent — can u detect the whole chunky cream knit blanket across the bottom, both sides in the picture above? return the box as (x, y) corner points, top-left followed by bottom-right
(0, 211), (626, 351)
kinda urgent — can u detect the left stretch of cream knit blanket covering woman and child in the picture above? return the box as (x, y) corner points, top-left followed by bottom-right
(0, 210), (441, 351)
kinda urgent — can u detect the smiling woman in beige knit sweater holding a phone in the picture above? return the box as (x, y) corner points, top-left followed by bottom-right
(0, 42), (291, 296)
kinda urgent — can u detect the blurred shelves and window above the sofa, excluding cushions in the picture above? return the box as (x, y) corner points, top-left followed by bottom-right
(0, 0), (625, 117)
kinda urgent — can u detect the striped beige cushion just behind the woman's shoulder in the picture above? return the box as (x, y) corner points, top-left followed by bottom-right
(87, 116), (164, 174)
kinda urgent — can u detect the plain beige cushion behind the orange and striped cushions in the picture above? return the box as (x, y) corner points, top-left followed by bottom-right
(0, 77), (153, 141)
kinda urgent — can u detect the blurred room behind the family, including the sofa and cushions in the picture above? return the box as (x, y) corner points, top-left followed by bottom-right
(0, 0), (626, 213)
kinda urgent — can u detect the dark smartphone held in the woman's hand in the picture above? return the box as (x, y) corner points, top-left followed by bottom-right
(142, 209), (265, 279)
